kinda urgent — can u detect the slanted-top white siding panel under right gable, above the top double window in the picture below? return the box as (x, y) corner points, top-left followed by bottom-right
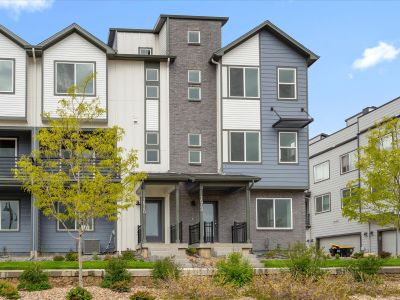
(222, 34), (260, 66)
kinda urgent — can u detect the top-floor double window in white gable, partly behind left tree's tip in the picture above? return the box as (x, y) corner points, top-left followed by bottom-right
(55, 62), (95, 95)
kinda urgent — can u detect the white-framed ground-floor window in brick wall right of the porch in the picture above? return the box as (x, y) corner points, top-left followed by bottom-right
(256, 198), (292, 229)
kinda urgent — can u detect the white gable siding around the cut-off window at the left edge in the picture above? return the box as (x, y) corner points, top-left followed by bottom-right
(0, 34), (26, 118)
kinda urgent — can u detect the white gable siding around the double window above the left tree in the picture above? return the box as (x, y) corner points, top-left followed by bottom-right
(43, 33), (107, 119)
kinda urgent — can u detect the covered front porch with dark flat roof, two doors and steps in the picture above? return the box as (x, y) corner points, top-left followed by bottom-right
(137, 173), (259, 256)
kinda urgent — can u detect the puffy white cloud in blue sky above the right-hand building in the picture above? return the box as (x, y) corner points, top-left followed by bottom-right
(353, 42), (400, 70)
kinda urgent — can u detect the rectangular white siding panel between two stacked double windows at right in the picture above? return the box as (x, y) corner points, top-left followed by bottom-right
(222, 99), (260, 130)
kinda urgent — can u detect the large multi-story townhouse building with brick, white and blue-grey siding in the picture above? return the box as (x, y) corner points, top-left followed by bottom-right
(0, 15), (318, 255)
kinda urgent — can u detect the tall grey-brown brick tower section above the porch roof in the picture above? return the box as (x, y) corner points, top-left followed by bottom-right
(169, 19), (221, 173)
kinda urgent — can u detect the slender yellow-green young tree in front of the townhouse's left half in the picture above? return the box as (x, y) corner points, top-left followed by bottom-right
(14, 76), (145, 287)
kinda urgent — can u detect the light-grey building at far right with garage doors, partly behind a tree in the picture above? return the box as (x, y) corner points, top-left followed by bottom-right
(306, 98), (400, 254)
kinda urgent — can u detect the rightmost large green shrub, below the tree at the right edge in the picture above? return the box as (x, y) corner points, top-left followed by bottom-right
(347, 256), (383, 282)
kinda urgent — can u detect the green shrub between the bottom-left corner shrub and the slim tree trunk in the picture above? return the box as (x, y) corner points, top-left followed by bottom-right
(18, 263), (51, 291)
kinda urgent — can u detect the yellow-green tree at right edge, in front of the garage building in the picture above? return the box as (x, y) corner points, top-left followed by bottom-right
(342, 118), (400, 256)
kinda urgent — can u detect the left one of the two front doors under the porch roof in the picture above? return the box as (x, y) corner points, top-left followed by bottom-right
(146, 199), (163, 242)
